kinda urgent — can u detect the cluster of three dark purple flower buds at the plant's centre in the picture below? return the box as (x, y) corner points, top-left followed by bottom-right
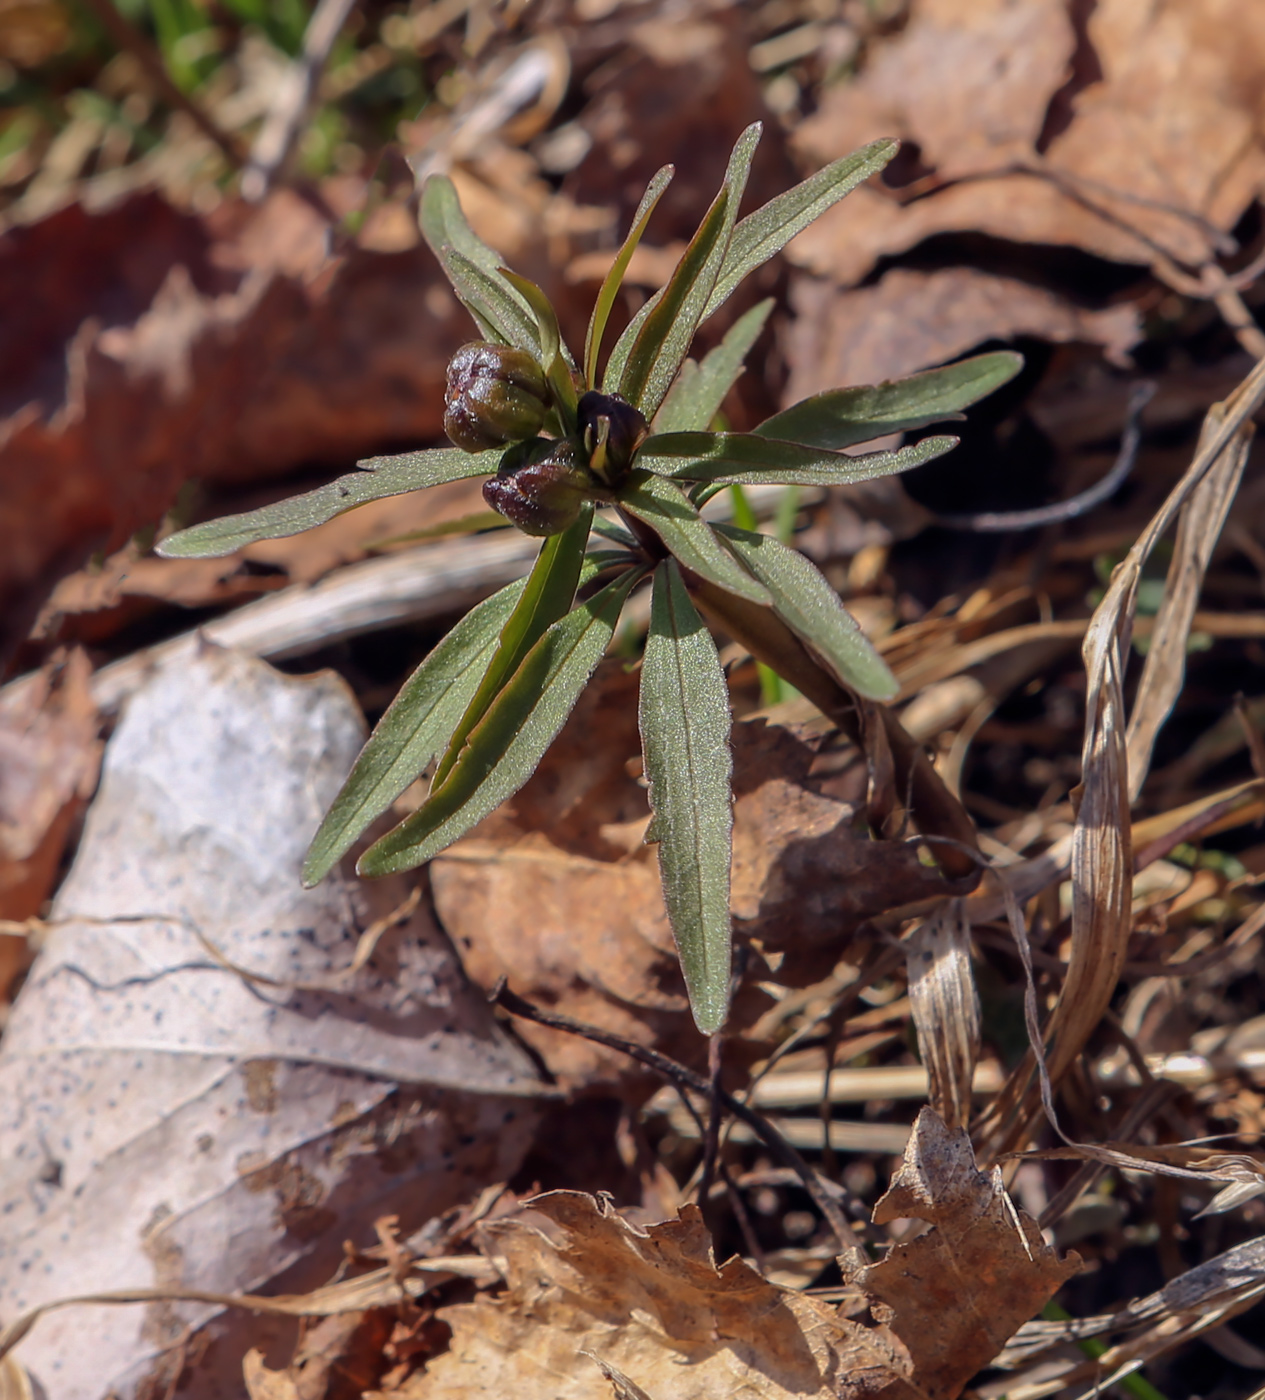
(444, 342), (649, 535)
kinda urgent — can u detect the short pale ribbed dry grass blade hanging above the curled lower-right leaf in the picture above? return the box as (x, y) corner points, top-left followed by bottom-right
(905, 899), (980, 1128)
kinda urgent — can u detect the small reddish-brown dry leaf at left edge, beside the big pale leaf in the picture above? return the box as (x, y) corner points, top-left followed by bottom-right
(0, 651), (101, 924)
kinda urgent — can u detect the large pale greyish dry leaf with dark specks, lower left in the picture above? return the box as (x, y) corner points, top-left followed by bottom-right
(0, 647), (540, 1400)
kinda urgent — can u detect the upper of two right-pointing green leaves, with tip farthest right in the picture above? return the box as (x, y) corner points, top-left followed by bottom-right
(756, 350), (1023, 449)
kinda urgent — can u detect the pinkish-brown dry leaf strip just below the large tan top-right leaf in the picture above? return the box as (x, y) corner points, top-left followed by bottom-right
(785, 266), (1142, 403)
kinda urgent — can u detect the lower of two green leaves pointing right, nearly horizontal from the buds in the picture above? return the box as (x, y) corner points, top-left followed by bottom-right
(637, 433), (957, 486)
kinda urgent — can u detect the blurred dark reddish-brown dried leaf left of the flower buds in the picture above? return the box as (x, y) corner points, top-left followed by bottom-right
(0, 192), (467, 652)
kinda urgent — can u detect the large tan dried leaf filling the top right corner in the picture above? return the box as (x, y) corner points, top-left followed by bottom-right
(789, 0), (1265, 284)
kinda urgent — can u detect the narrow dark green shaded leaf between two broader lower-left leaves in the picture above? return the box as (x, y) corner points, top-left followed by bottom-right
(431, 505), (593, 790)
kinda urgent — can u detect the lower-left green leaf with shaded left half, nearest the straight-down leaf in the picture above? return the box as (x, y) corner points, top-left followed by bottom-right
(357, 568), (644, 875)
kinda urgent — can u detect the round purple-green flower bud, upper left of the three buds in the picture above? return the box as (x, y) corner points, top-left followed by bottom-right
(444, 340), (549, 452)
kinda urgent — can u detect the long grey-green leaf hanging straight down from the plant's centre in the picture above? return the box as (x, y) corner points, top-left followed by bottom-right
(638, 559), (733, 1035)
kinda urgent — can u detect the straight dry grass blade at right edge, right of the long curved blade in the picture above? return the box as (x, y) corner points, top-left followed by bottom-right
(1125, 410), (1252, 802)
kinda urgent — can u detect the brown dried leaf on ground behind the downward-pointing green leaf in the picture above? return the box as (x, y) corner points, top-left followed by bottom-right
(430, 661), (947, 1089)
